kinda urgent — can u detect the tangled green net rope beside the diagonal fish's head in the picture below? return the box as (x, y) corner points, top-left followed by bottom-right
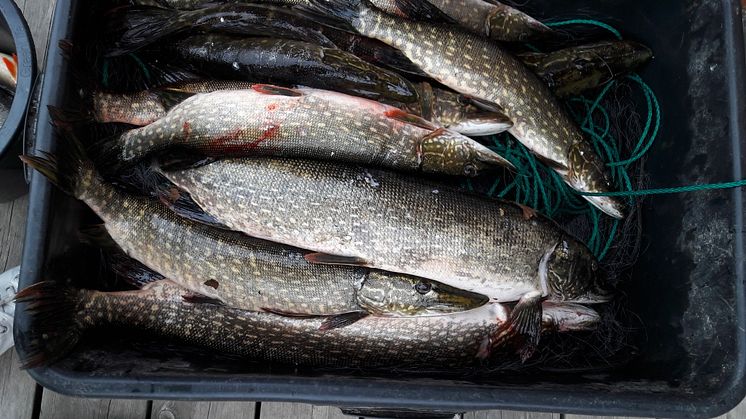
(467, 19), (661, 260)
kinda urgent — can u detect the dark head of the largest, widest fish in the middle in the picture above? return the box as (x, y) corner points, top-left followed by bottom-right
(539, 235), (613, 303)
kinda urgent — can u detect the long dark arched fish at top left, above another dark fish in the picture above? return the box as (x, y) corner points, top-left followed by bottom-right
(107, 3), (425, 76)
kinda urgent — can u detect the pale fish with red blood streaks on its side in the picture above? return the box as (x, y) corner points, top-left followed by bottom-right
(97, 84), (512, 177)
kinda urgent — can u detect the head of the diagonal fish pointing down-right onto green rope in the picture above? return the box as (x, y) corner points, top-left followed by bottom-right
(565, 141), (625, 219)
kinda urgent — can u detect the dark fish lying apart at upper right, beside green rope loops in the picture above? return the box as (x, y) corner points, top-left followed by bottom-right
(518, 41), (653, 97)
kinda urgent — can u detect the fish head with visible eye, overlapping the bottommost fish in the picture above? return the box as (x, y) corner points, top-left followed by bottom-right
(357, 271), (489, 316)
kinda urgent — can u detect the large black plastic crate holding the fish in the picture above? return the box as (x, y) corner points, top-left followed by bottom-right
(15, 0), (746, 417)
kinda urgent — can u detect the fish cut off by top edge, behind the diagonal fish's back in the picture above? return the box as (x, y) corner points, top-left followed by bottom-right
(427, 0), (554, 42)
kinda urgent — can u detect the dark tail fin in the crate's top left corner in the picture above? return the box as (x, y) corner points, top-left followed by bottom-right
(106, 6), (196, 57)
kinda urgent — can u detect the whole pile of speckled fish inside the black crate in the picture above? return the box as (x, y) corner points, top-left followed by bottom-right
(18, 0), (651, 368)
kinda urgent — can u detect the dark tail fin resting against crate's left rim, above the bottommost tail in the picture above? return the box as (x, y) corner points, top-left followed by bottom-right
(21, 109), (100, 197)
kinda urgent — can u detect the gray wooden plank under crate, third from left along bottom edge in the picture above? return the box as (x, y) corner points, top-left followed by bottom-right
(151, 400), (256, 419)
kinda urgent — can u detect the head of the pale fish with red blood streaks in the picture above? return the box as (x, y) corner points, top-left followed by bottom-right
(420, 128), (514, 177)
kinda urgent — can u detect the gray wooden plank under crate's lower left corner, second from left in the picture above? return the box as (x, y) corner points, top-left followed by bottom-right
(39, 390), (148, 419)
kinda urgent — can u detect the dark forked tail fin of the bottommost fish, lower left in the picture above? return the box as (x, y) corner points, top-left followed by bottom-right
(15, 281), (85, 368)
